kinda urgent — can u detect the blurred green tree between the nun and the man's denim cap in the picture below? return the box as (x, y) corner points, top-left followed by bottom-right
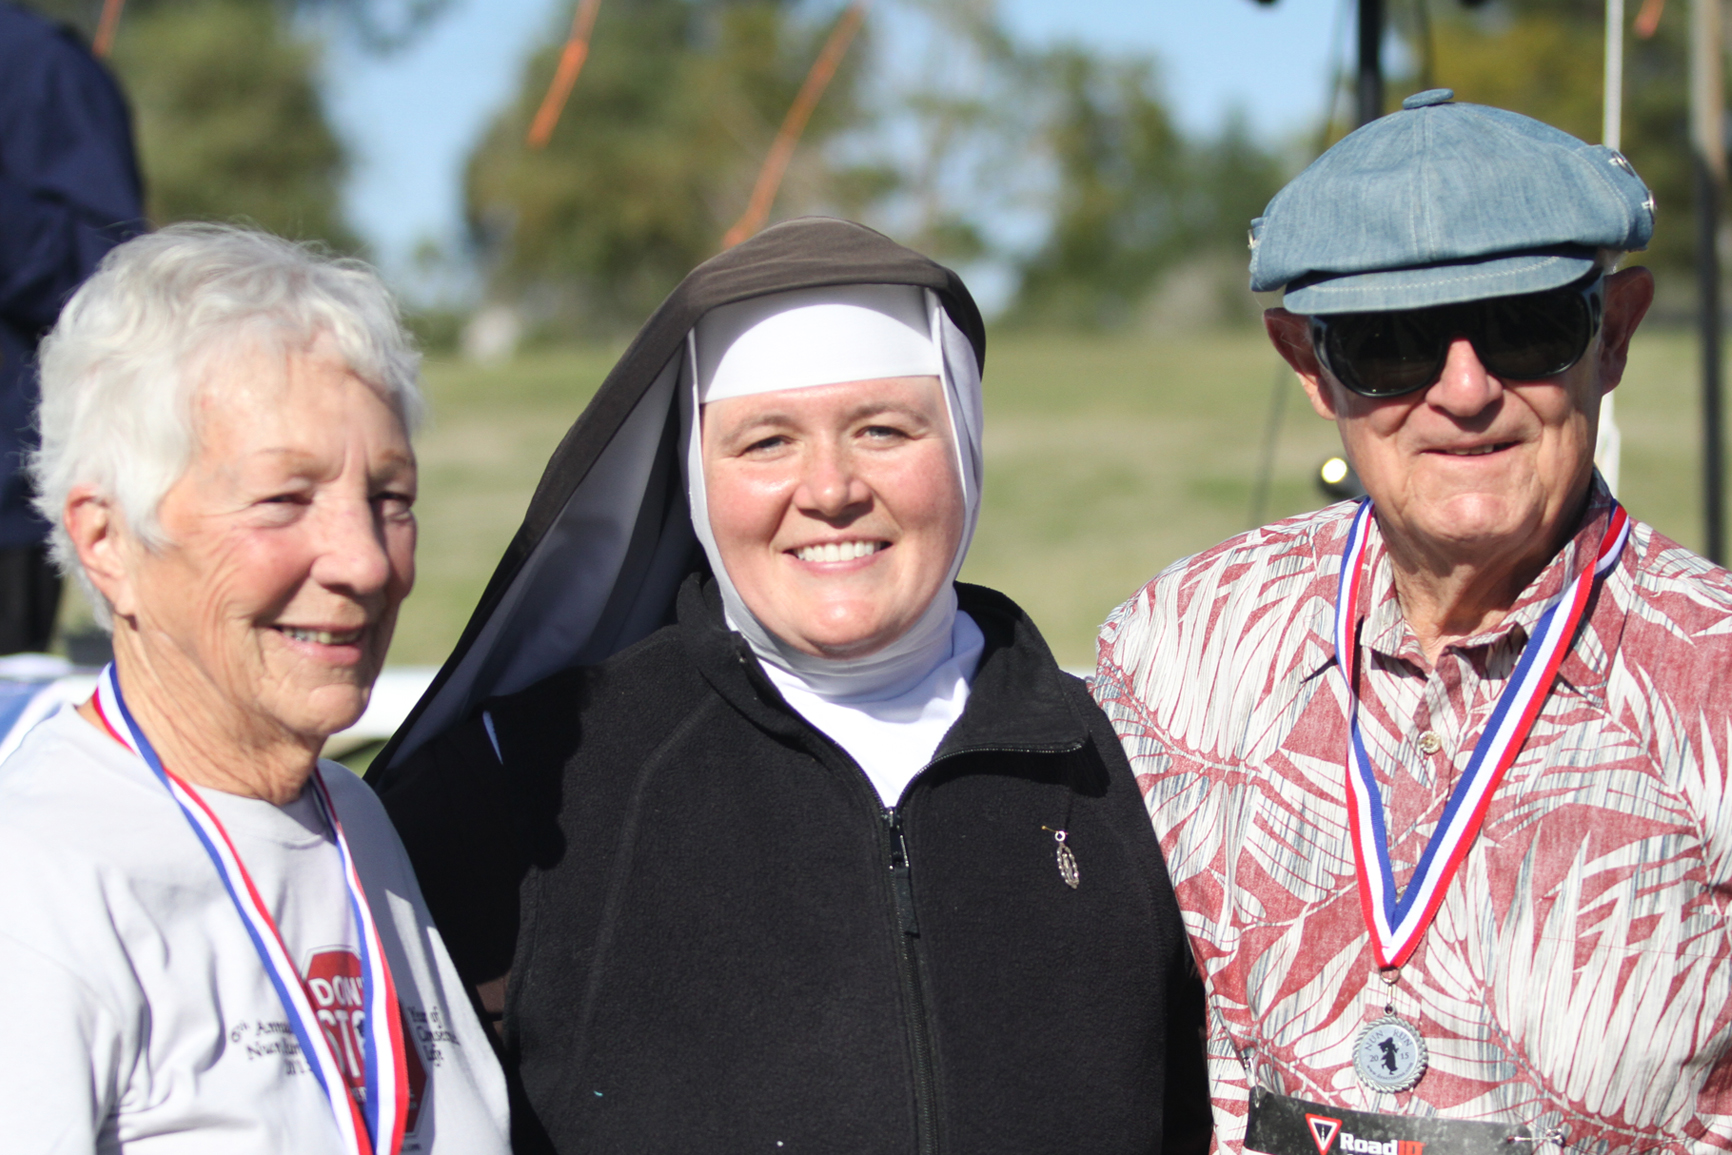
(1006, 47), (1282, 327)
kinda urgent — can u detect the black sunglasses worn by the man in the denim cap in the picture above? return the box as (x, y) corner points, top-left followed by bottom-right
(1311, 272), (1606, 397)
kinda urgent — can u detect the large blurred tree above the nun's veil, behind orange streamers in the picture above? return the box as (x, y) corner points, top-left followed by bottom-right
(466, 0), (872, 334)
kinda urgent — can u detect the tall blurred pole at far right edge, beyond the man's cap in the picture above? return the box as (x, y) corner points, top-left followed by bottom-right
(1690, 0), (1725, 565)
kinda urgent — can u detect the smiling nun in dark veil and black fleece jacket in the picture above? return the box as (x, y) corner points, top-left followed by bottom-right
(374, 218), (1209, 1155)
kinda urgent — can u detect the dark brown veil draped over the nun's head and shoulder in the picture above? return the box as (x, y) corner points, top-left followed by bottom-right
(374, 216), (986, 772)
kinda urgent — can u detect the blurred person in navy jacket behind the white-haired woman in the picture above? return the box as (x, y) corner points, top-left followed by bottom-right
(0, 0), (144, 653)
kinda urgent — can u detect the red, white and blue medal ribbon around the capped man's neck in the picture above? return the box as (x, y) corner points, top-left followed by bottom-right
(1335, 499), (1630, 966)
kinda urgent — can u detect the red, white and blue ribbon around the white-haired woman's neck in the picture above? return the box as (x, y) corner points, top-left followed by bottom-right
(94, 663), (409, 1155)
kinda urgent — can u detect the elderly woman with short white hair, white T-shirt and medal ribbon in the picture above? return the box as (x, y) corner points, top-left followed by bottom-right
(0, 227), (507, 1155)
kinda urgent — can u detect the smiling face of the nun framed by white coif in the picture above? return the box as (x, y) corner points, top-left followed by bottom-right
(703, 377), (963, 658)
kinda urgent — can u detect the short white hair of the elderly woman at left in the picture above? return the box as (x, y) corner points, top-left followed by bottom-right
(29, 225), (423, 625)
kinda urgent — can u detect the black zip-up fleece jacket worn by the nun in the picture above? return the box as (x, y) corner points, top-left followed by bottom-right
(381, 575), (1209, 1155)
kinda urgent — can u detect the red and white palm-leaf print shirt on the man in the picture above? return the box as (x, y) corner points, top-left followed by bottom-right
(1079, 485), (1732, 1155)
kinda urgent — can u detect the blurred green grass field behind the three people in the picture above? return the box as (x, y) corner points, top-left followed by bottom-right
(391, 331), (1701, 665)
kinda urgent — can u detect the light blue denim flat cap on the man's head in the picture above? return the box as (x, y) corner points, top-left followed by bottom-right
(1251, 88), (1654, 313)
